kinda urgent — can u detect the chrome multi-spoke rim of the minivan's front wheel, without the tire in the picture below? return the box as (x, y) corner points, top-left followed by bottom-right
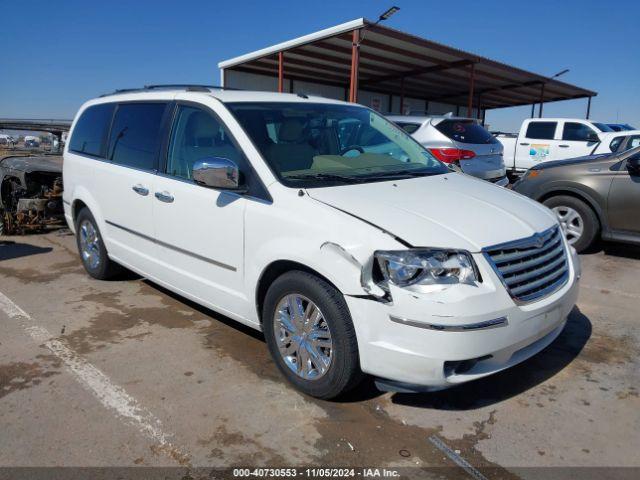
(273, 293), (333, 380)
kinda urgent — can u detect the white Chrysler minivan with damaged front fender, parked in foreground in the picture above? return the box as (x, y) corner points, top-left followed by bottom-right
(63, 86), (580, 398)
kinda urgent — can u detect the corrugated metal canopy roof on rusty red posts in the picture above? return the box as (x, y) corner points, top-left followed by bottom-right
(218, 18), (597, 109)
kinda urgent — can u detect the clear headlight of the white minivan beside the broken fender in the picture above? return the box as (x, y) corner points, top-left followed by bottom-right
(375, 248), (478, 291)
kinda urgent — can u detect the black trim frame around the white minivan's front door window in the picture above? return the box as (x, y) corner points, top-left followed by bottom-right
(155, 100), (273, 204)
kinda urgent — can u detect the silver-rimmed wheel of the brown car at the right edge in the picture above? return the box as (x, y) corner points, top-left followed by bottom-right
(543, 195), (600, 252)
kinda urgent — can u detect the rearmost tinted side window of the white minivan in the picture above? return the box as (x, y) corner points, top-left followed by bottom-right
(69, 103), (115, 157)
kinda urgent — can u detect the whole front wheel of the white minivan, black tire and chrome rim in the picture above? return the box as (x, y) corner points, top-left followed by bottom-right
(262, 271), (362, 399)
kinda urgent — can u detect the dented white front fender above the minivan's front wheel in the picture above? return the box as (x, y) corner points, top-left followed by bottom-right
(245, 189), (405, 320)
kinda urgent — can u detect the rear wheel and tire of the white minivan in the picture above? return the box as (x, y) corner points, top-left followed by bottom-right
(76, 208), (123, 280)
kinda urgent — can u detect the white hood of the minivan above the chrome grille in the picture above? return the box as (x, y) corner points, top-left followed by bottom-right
(307, 173), (557, 252)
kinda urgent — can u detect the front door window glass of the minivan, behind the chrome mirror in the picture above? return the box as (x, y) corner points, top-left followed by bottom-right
(167, 105), (242, 180)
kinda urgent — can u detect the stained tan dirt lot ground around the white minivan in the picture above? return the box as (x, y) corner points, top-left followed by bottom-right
(0, 232), (640, 479)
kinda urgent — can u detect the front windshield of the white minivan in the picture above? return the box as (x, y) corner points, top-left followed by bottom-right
(227, 102), (449, 187)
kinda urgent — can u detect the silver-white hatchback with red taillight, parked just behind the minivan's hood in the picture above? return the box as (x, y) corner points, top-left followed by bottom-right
(387, 115), (509, 187)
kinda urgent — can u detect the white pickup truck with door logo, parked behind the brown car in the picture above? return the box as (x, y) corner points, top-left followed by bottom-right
(496, 118), (612, 174)
